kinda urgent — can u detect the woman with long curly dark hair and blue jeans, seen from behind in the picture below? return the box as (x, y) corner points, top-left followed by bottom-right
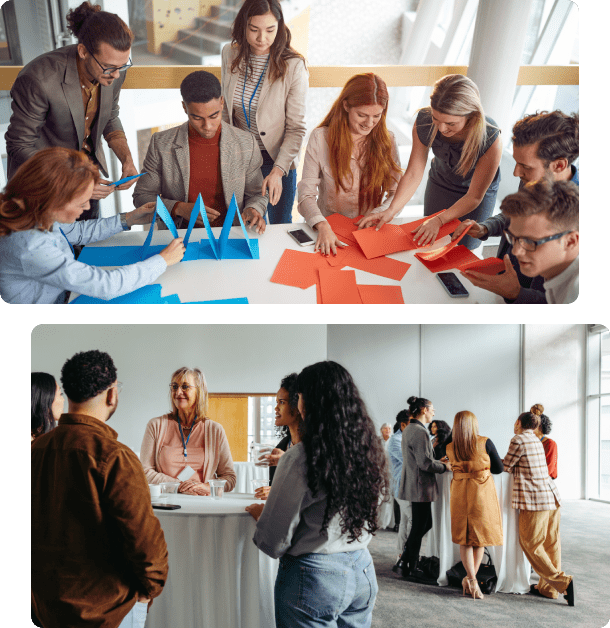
(246, 361), (390, 628)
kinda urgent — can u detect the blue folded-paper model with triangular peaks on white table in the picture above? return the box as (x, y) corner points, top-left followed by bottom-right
(78, 194), (259, 266)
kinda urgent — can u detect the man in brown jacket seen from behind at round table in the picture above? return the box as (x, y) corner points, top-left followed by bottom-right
(32, 351), (168, 628)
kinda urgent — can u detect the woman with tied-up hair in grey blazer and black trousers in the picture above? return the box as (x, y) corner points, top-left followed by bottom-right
(394, 397), (451, 579)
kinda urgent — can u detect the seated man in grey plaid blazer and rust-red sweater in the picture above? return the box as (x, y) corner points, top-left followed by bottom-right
(133, 70), (268, 233)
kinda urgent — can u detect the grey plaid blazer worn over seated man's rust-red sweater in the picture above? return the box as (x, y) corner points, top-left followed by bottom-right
(133, 122), (268, 221)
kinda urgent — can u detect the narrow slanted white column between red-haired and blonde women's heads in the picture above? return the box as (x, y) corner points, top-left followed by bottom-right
(389, 0), (445, 115)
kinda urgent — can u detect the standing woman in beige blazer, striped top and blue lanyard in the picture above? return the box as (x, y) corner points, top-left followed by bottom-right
(221, 0), (309, 224)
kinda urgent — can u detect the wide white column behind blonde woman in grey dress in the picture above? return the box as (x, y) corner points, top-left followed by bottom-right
(468, 0), (532, 144)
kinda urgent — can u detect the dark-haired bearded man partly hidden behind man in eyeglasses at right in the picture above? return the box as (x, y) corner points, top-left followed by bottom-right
(452, 110), (579, 303)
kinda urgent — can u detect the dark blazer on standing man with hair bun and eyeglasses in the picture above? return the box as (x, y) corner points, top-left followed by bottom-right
(5, 45), (125, 179)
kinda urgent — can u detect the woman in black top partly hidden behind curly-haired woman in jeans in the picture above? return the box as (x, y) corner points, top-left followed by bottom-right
(254, 373), (303, 499)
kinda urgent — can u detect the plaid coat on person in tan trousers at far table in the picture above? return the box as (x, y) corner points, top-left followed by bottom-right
(503, 430), (561, 510)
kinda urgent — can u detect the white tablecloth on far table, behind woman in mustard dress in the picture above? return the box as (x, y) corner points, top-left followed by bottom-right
(427, 472), (530, 593)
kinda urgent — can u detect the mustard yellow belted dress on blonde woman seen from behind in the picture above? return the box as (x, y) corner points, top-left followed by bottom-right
(447, 436), (504, 547)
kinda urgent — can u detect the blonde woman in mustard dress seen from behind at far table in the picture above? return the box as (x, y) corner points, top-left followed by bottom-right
(447, 410), (504, 599)
